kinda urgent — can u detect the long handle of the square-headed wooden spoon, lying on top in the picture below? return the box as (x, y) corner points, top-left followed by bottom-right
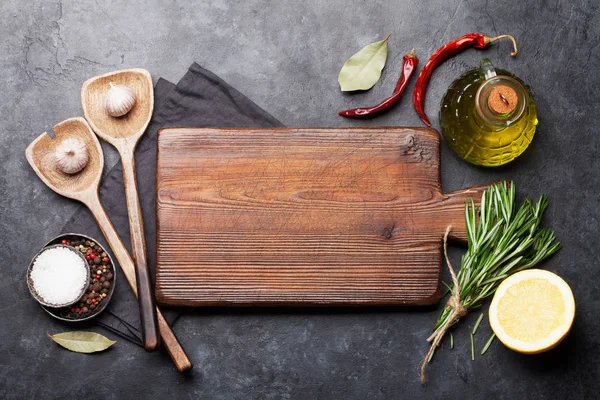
(121, 150), (160, 351)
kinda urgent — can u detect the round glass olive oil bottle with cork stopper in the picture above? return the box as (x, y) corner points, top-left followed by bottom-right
(440, 58), (538, 167)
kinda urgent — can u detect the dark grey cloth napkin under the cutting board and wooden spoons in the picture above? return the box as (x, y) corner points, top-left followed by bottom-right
(63, 63), (283, 345)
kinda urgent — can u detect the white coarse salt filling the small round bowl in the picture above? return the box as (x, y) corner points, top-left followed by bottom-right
(30, 247), (88, 305)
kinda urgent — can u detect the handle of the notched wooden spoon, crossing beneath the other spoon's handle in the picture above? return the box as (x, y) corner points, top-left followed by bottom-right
(80, 192), (192, 372)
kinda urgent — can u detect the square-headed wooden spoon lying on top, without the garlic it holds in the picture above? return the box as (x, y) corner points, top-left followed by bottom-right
(81, 69), (160, 351)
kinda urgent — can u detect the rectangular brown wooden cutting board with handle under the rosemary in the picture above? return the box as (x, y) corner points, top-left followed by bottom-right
(156, 128), (486, 306)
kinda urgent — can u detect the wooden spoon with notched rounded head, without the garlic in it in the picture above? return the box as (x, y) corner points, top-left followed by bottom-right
(25, 118), (192, 372)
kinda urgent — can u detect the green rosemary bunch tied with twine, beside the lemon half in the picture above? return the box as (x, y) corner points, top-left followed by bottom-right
(421, 182), (560, 383)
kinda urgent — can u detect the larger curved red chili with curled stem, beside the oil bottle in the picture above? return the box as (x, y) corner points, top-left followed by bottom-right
(413, 33), (518, 126)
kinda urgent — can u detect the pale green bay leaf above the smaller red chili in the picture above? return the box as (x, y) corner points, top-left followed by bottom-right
(338, 35), (390, 92)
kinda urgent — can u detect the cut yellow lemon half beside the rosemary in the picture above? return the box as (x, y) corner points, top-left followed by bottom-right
(489, 269), (575, 354)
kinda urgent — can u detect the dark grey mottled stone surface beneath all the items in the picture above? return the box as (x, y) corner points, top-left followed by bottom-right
(0, 0), (600, 399)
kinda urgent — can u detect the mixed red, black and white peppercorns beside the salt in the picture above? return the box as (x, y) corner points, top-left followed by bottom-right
(58, 239), (114, 319)
